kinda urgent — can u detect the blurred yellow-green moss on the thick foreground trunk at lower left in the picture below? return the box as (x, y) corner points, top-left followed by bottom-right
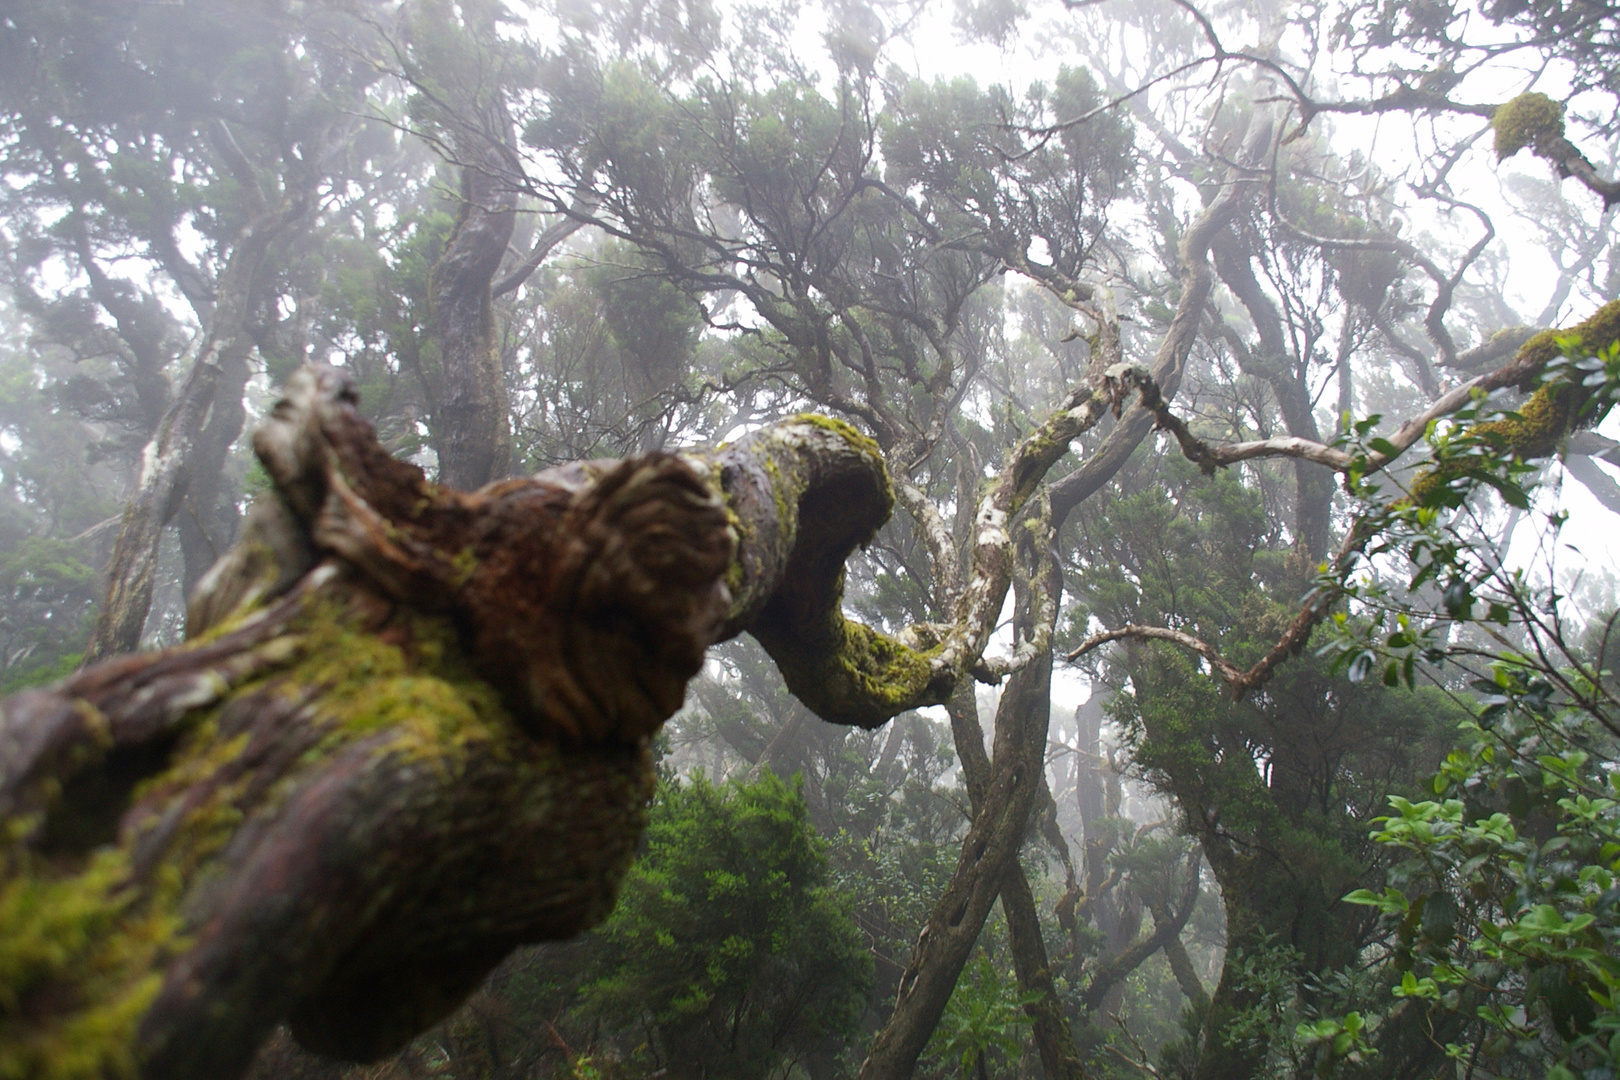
(0, 597), (515, 1080)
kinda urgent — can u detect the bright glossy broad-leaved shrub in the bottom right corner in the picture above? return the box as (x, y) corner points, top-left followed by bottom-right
(1348, 680), (1620, 1075)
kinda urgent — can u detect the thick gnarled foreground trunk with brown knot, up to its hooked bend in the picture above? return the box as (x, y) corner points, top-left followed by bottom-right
(0, 368), (926, 1080)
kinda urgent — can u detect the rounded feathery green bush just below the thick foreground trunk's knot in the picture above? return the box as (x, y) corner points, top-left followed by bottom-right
(580, 774), (872, 1078)
